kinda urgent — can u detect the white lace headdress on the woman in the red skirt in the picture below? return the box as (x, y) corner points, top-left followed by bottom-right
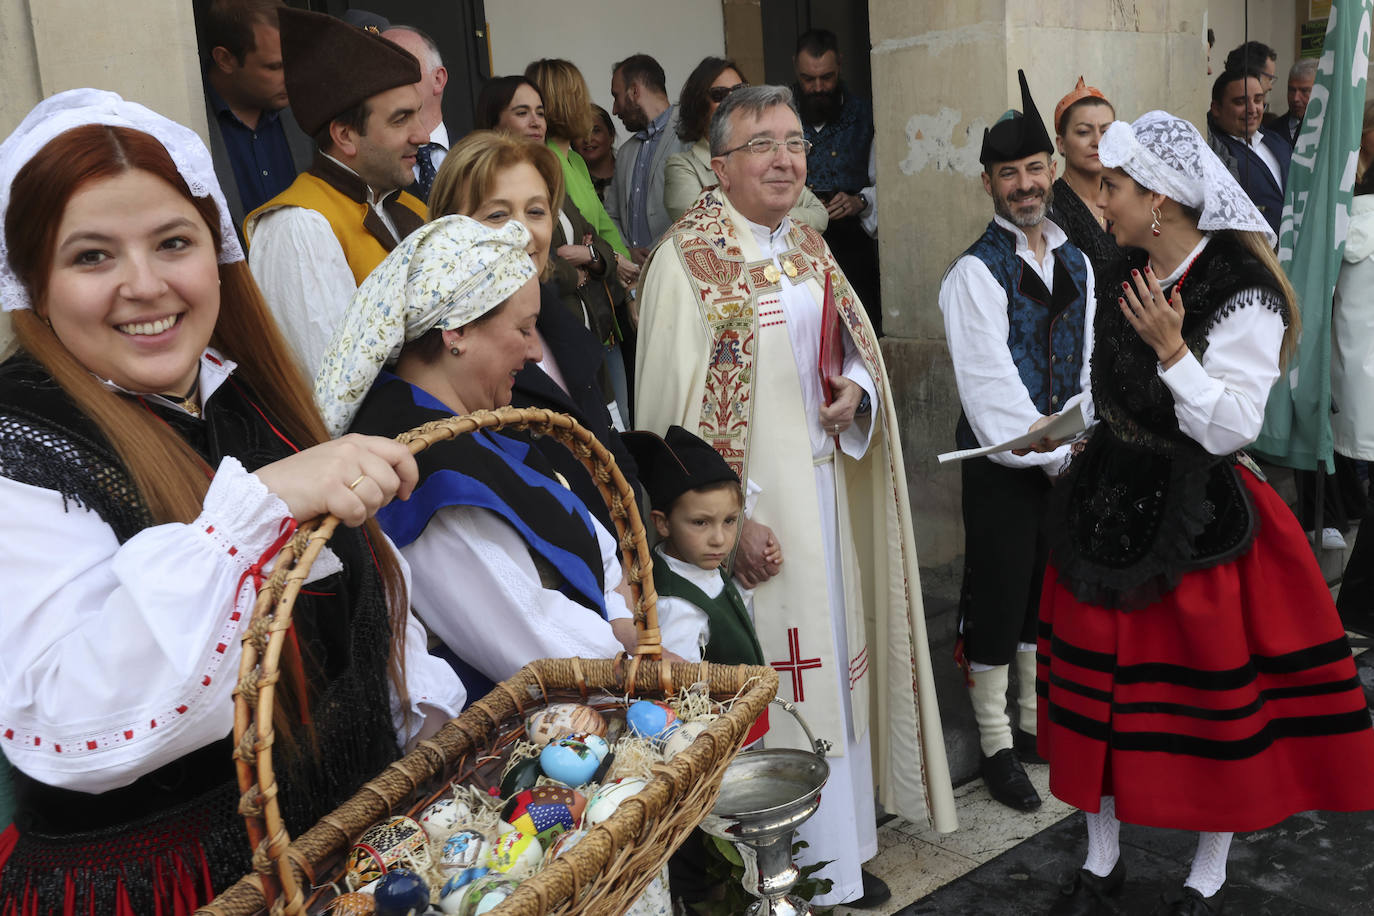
(1098, 111), (1278, 247)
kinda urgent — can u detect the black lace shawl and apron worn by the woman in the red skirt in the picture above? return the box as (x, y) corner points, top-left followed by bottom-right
(1048, 235), (1287, 610)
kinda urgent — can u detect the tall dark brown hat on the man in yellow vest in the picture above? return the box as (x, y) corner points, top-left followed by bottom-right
(278, 7), (420, 137)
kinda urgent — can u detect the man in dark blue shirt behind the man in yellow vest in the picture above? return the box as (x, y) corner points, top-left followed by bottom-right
(202, 0), (315, 235)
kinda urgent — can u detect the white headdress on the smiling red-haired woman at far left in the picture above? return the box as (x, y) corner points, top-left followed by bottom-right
(0, 89), (243, 312)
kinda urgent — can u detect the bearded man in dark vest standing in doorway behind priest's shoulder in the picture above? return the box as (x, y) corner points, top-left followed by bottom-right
(791, 29), (882, 336)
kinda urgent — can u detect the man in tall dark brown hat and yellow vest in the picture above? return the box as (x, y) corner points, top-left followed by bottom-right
(243, 8), (429, 376)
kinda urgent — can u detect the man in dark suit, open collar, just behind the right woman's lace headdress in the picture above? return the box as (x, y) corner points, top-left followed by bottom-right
(1206, 69), (1293, 235)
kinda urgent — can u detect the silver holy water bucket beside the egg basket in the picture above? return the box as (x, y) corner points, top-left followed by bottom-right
(701, 698), (830, 916)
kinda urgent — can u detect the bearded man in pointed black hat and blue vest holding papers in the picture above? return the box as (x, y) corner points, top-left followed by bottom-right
(940, 71), (1095, 810)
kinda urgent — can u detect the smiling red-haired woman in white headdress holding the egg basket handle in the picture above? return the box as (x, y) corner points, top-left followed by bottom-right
(0, 89), (463, 915)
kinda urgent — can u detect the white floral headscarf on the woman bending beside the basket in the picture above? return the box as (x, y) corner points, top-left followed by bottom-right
(315, 216), (534, 435)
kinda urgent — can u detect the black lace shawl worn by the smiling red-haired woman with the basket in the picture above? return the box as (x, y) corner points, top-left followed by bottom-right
(0, 353), (398, 913)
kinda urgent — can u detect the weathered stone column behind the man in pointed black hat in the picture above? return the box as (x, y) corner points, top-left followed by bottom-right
(868, 0), (1209, 603)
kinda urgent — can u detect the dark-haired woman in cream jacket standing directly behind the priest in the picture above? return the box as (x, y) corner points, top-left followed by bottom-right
(664, 58), (830, 232)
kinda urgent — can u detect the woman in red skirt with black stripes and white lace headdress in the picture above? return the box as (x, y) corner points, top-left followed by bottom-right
(1039, 111), (1374, 913)
